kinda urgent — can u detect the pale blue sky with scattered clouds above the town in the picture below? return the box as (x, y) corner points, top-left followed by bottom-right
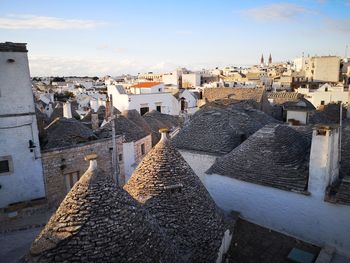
(0, 0), (350, 76)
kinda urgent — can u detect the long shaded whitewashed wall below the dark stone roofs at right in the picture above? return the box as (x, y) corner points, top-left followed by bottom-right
(180, 150), (350, 257)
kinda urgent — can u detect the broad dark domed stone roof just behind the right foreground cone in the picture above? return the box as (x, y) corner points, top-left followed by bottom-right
(172, 100), (279, 154)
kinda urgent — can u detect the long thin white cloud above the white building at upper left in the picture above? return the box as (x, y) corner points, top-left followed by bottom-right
(0, 15), (106, 30)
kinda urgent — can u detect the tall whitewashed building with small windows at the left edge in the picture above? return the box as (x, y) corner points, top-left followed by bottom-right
(0, 42), (45, 208)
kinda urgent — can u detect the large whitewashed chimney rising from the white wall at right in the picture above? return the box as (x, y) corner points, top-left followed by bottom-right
(308, 125), (339, 200)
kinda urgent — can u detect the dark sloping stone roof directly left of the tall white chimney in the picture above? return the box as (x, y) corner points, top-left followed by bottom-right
(208, 124), (312, 193)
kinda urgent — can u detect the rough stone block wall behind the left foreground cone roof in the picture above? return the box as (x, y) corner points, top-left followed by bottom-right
(42, 137), (125, 207)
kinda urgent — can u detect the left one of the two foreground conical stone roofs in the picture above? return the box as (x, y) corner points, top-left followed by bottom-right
(26, 156), (179, 262)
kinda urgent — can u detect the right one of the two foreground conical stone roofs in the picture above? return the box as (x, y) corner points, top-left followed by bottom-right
(124, 131), (224, 262)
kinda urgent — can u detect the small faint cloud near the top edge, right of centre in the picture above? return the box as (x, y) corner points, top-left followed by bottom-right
(241, 3), (310, 21)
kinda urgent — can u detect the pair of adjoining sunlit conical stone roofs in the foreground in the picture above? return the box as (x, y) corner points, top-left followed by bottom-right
(24, 130), (229, 262)
